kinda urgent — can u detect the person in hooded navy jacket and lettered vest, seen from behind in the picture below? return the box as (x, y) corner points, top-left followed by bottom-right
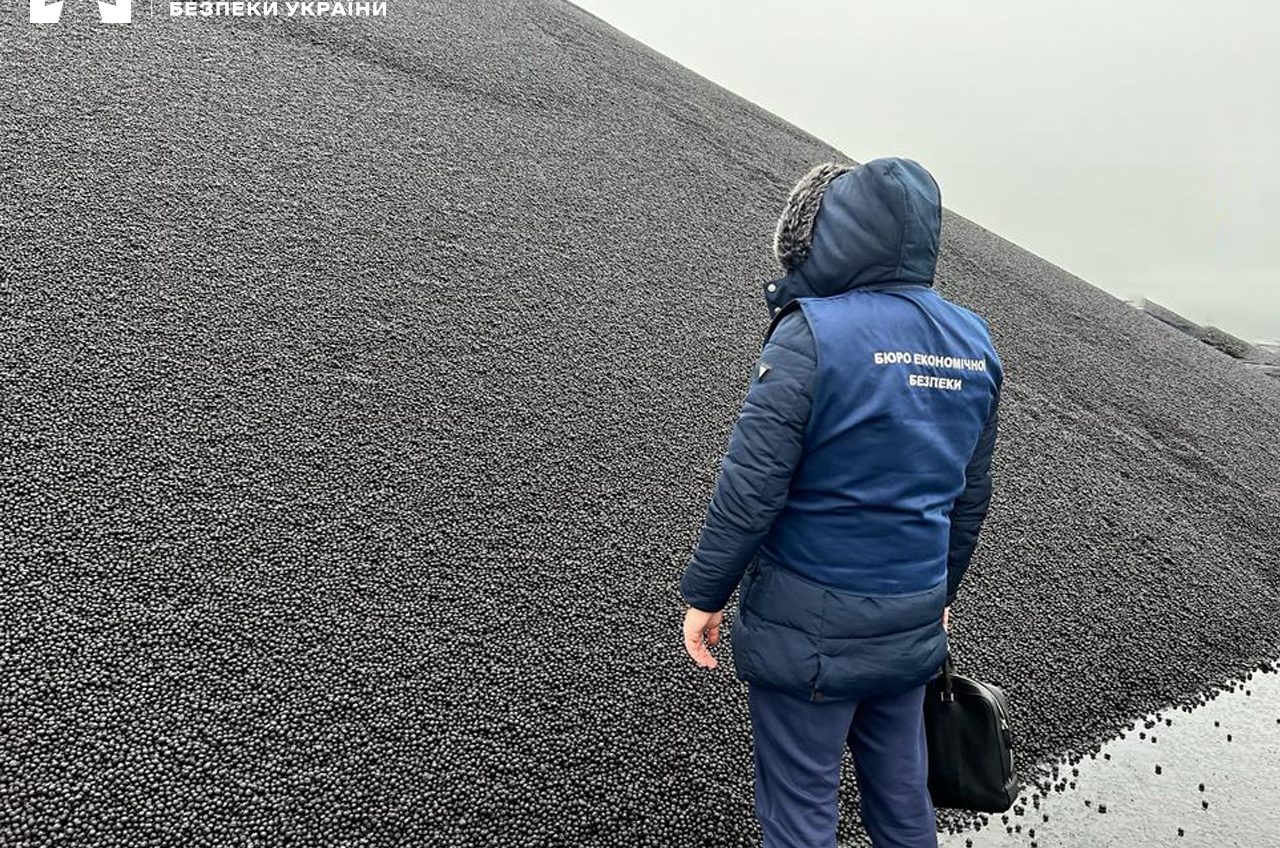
(680, 158), (1002, 848)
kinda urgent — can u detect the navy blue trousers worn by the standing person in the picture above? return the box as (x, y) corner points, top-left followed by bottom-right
(748, 684), (938, 848)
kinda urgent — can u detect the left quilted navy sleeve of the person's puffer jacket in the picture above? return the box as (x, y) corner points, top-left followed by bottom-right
(680, 309), (818, 612)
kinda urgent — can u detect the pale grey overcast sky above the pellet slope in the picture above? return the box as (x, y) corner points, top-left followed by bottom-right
(577, 0), (1280, 341)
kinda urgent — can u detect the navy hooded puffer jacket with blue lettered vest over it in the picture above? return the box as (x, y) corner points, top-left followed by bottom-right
(681, 159), (1002, 701)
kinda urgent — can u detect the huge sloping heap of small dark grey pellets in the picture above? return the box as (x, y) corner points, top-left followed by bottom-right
(0, 1), (1280, 847)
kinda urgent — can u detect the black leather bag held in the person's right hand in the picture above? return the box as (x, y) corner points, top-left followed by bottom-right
(924, 653), (1018, 812)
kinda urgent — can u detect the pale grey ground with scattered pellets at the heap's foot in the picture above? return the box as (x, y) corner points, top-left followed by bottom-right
(938, 666), (1280, 848)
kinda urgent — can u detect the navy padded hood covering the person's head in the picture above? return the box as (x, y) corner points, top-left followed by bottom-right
(764, 156), (942, 316)
